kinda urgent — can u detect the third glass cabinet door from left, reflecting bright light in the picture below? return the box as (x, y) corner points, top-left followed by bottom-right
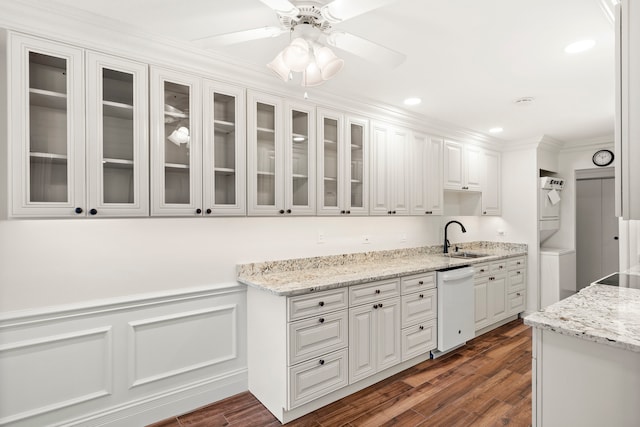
(151, 69), (203, 215)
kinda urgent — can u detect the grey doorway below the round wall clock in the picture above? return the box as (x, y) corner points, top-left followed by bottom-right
(576, 168), (619, 290)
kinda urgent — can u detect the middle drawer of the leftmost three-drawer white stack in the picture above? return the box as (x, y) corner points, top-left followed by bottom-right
(289, 310), (349, 365)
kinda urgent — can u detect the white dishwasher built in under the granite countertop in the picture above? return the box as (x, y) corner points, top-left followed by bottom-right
(431, 266), (475, 358)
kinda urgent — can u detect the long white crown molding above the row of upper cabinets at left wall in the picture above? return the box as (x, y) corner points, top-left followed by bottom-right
(0, 0), (505, 151)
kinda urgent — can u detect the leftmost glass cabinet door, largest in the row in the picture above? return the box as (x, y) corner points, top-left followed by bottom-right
(9, 34), (86, 216)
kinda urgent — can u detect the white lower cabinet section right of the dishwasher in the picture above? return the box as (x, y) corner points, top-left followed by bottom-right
(474, 257), (526, 332)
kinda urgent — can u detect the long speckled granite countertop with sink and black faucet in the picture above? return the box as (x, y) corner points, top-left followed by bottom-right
(237, 242), (527, 296)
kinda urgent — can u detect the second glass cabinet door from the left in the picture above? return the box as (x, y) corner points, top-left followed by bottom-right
(87, 52), (149, 216)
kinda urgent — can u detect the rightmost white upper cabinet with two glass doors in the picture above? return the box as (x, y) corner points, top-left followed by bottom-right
(317, 108), (368, 215)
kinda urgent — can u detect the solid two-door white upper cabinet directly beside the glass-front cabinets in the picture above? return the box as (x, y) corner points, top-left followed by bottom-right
(369, 123), (411, 215)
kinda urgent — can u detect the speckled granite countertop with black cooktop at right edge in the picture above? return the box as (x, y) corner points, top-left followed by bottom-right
(524, 285), (640, 352)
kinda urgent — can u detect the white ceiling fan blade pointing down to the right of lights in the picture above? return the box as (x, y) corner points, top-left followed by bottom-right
(327, 31), (407, 68)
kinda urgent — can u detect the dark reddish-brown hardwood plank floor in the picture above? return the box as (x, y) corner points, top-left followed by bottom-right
(153, 320), (531, 427)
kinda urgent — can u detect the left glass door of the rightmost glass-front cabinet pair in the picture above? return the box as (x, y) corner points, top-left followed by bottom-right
(318, 110), (347, 214)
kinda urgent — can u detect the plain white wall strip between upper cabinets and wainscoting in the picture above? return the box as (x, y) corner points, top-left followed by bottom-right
(0, 217), (450, 312)
